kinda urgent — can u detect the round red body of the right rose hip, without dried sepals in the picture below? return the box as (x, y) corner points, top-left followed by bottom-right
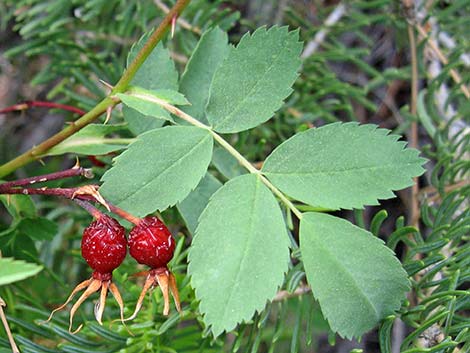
(129, 216), (175, 268)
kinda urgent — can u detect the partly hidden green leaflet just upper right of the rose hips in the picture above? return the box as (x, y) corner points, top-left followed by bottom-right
(177, 173), (222, 234)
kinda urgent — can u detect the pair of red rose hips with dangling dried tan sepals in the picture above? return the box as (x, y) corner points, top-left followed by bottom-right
(48, 214), (181, 333)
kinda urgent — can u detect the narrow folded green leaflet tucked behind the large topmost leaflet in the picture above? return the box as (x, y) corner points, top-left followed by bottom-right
(180, 27), (229, 124)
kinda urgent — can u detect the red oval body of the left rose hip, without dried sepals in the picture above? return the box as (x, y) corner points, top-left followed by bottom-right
(82, 215), (127, 279)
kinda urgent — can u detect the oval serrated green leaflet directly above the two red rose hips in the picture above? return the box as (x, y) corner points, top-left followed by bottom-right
(100, 126), (213, 216)
